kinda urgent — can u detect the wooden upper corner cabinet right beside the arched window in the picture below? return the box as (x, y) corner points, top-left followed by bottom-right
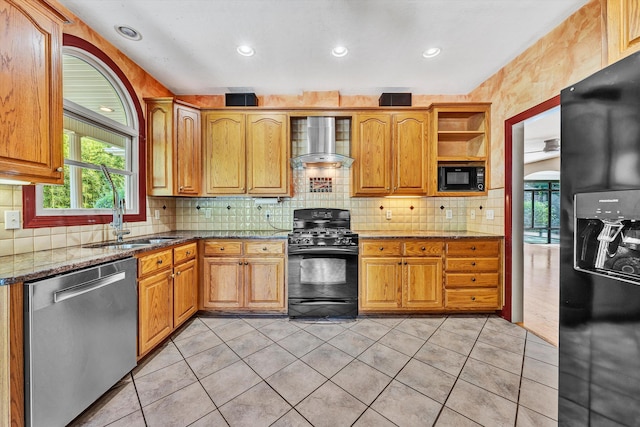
(145, 98), (201, 196)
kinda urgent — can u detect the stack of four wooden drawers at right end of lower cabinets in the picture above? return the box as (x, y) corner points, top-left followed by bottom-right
(445, 239), (502, 310)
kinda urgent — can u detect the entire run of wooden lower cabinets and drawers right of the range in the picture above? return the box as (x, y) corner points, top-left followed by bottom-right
(359, 238), (502, 313)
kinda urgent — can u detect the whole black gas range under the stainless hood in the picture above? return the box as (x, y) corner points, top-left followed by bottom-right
(288, 208), (358, 318)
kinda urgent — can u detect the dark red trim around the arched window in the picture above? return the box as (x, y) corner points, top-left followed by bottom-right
(22, 34), (147, 228)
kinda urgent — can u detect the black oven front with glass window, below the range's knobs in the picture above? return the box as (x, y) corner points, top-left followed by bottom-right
(289, 247), (358, 317)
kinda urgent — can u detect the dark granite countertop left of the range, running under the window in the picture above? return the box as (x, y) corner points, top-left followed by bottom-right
(0, 230), (289, 286)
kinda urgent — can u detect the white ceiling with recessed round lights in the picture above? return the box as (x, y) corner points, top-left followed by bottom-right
(59, 0), (588, 95)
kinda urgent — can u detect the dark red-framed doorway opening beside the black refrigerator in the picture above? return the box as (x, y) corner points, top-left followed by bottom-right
(503, 96), (561, 345)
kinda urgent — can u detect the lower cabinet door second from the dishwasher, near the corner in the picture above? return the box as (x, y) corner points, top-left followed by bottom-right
(173, 259), (198, 328)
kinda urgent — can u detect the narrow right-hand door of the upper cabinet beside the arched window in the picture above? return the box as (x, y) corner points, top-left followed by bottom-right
(174, 104), (202, 196)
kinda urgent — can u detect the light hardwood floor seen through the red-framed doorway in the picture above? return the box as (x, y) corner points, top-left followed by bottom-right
(522, 243), (560, 346)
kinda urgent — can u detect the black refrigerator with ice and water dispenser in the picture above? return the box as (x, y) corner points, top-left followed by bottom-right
(558, 49), (640, 426)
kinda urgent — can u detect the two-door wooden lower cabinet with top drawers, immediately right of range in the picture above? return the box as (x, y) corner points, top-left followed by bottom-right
(359, 239), (442, 312)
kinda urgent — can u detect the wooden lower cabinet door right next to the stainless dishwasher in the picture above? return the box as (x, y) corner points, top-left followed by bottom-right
(138, 270), (173, 355)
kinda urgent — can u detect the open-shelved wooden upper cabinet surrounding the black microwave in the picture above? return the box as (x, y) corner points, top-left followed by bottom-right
(429, 103), (491, 196)
